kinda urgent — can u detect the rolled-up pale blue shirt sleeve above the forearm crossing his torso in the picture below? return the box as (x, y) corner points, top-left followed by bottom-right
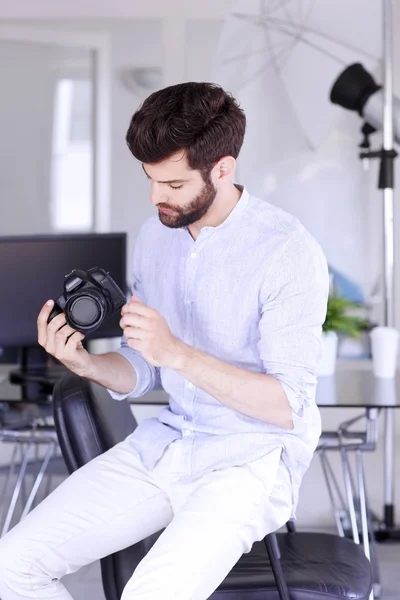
(258, 236), (329, 422)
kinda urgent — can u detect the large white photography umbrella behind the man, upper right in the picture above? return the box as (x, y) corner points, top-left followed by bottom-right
(213, 0), (382, 193)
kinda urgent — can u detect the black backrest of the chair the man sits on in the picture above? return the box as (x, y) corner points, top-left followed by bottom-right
(53, 373), (137, 473)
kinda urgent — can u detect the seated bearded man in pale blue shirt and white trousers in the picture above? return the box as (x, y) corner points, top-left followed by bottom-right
(0, 83), (329, 600)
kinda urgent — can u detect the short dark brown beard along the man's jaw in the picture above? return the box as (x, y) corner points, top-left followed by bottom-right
(158, 180), (217, 229)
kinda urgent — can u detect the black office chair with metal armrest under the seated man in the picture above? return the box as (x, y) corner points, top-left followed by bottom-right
(53, 374), (372, 600)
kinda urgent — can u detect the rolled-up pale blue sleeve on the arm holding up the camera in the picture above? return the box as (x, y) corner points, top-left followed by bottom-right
(108, 227), (161, 400)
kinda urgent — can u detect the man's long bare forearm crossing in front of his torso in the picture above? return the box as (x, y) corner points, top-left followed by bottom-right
(172, 343), (293, 429)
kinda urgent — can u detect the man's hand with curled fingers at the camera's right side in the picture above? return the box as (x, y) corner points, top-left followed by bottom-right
(120, 296), (185, 369)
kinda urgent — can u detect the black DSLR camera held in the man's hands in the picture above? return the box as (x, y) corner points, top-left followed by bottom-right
(48, 267), (126, 334)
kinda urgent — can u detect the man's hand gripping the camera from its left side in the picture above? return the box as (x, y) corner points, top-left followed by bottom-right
(37, 300), (92, 377)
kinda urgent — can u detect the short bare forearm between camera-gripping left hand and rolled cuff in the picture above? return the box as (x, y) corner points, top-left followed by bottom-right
(83, 352), (137, 394)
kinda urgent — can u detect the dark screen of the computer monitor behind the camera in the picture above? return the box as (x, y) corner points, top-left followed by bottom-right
(0, 233), (127, 347)
